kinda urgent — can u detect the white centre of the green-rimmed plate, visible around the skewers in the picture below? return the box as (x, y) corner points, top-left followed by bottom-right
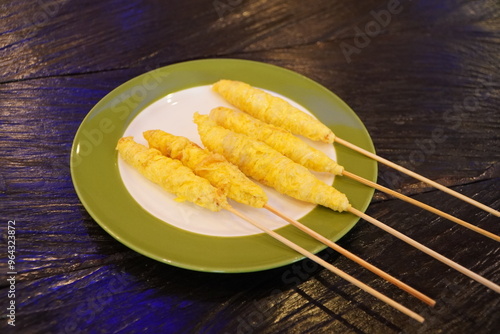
(118, 86), (336, 237)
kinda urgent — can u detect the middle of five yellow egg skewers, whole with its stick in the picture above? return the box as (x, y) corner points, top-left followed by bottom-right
(194, 113), (500, 292)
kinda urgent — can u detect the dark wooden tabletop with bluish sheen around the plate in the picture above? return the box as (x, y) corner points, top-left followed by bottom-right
(0, 0), (500, 333)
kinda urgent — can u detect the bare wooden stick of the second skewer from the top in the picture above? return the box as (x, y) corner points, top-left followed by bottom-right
(342, 171), (500, 241)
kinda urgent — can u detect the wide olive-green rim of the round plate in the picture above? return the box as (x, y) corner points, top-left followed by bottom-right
(71, 59), (377, 273)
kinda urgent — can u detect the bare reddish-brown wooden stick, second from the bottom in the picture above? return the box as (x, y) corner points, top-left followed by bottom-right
(264, 204), (436, 306)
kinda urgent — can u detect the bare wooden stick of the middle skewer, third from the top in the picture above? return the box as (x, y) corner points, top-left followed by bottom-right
(347, 206), (500, 293)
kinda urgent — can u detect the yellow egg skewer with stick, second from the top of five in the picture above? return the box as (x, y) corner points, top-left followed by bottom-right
(209, 107), (500, 241)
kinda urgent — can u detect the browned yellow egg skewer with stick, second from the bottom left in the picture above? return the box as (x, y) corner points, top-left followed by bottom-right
(143, 130), (436, 306)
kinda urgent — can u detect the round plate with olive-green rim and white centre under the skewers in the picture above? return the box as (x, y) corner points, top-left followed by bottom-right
(71, 59), (377, 273)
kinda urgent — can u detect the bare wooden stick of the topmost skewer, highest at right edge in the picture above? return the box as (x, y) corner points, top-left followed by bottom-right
(335, 137), (500, 217)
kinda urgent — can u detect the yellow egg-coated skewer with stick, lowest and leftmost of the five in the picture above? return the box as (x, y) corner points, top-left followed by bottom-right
(116, 137), (424, 322)
